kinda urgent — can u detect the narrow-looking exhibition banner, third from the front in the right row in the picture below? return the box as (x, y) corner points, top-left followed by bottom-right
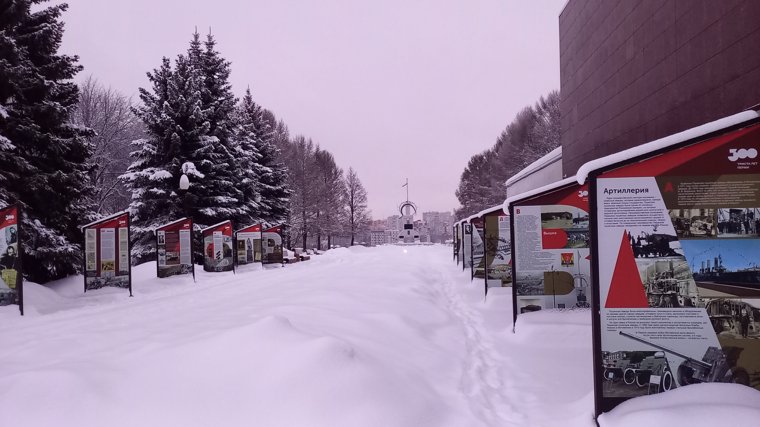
(483, 208), (512, 292)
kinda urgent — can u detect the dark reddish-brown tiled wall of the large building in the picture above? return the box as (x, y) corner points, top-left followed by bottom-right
(559, 0), (760, 176)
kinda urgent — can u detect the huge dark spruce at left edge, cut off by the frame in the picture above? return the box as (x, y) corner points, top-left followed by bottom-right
(0, 0), (92, 282)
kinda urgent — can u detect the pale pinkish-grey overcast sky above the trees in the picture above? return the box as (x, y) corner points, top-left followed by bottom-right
(62, 0), (565, 218)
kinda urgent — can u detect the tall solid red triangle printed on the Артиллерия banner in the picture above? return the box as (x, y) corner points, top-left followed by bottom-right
(604, 231), (649, 308)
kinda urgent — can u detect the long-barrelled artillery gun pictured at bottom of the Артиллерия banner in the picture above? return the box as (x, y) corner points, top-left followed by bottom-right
(619, 331), (749, 391)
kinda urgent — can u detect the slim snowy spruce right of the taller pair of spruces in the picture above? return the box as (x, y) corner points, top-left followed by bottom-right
(236, 89), (291, 223)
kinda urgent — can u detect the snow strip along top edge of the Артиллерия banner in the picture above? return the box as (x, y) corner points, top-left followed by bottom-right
(575, 110), (760, 185)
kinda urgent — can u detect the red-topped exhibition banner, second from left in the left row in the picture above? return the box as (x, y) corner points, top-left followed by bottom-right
(82, 212), (132, 296)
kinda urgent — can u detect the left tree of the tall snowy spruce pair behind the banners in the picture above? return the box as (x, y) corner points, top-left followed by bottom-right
(122, 55), (210, 262)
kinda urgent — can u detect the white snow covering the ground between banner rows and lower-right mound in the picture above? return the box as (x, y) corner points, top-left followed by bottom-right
(0, 246), (760, 427)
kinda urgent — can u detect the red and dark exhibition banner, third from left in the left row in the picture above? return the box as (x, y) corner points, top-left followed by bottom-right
(156, 218), (195, 278)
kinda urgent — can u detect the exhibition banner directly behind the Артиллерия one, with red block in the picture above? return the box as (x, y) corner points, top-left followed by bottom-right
(510, 180), (591, 321)
